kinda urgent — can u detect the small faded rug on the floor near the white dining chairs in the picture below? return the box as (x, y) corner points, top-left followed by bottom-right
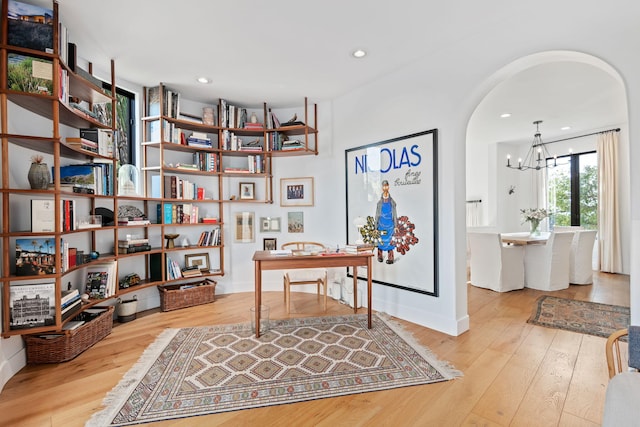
(528, 295), (630, 338)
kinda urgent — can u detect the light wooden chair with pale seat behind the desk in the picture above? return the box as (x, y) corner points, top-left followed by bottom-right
(282, 242), (327, 313)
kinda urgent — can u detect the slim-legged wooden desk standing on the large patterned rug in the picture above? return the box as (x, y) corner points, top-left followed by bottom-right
(253, 251), (373, 338)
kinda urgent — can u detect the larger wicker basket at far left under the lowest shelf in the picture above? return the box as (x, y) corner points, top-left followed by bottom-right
(24, 307), (113, 363)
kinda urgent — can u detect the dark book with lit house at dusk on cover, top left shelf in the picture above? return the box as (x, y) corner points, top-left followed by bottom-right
(7, 0), (53, 53)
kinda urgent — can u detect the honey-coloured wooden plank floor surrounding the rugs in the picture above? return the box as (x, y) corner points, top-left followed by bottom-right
(0, 274), (629, 427)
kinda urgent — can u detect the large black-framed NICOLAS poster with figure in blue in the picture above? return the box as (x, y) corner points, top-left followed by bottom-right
(345, 129), (438, 297)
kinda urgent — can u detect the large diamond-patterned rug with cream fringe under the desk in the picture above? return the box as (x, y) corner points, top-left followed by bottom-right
(86, 314), (461, 426)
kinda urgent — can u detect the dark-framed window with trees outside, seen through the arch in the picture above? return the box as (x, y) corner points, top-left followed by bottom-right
(547, 151), (598, 230)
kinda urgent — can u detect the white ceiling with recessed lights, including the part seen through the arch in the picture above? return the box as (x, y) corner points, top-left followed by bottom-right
(52, 0), (626, 142)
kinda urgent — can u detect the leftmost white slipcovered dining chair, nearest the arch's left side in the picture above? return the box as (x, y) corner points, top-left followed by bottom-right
(467, 233), (524, 292)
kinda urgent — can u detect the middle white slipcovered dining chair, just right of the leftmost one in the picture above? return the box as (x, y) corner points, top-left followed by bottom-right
(524, 232), (574, 291)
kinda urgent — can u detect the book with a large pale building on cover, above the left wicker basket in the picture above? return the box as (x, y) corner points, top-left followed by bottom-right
(9, 283), (56, 329)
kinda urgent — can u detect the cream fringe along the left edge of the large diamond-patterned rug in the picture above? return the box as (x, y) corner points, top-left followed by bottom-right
(85, 329), (180, 427)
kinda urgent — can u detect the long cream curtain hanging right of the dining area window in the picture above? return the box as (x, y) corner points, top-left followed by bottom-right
(598, 131), (622, 273)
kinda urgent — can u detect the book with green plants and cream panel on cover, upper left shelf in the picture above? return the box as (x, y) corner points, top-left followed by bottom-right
(7, 53), (53, 95)
